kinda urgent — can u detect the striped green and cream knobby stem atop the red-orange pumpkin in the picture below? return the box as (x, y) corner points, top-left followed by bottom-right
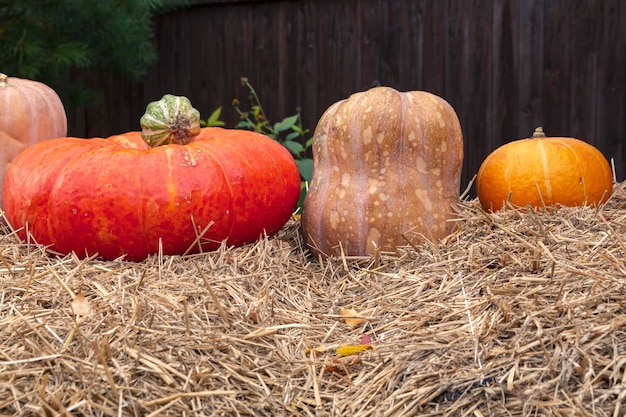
(140, 94), (200, 147)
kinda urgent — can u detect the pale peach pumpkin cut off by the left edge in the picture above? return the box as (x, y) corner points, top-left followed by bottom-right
(0, 73), (67, 208)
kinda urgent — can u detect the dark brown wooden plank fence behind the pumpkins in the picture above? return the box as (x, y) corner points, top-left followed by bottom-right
(69, 0), (626, 188)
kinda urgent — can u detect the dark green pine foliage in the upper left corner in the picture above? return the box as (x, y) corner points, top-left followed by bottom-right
(0, 0), (186, 105)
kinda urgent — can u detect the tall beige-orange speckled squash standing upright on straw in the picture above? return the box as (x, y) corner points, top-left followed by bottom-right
(302, 87), (463, 256)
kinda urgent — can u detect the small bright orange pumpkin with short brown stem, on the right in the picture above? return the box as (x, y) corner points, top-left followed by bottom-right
(476, 127), (613, 211)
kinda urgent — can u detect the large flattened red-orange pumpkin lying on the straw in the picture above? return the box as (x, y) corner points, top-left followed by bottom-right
(4, 97), (300, 260)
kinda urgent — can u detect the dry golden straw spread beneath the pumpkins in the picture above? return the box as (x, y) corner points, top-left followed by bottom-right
(0, 185), (626, 417)
